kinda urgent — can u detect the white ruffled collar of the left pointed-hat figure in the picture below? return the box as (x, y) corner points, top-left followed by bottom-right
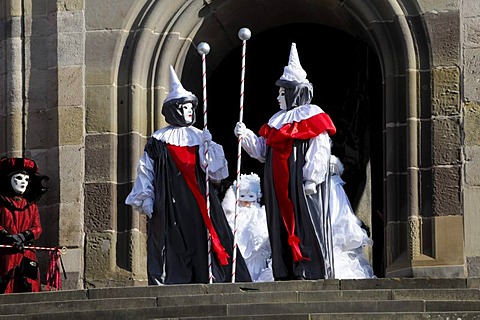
(152, 126), (202, 147)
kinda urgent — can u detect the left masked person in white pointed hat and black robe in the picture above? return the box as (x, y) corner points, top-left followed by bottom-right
(125, 66), (251, 285)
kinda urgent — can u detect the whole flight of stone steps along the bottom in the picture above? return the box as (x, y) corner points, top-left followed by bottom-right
(0, 278), (480, 320)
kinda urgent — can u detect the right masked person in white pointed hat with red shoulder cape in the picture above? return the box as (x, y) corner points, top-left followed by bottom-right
(235, 43), (336, 280)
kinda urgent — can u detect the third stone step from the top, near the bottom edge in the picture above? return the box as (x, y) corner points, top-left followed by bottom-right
(0, 299), (480, 320)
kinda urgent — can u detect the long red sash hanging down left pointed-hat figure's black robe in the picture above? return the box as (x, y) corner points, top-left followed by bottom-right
(167, 144), (230, 266)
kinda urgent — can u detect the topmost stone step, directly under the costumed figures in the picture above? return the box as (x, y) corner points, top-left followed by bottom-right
(0, 278), (480, 304)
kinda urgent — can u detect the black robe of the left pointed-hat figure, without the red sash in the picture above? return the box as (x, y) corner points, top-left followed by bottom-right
(145, 138), (251, 284)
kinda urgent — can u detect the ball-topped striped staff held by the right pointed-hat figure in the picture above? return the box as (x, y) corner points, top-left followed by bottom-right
(232, 28), (252, 283)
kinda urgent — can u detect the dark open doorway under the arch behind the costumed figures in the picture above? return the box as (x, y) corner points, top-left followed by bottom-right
(193, 24), (384, 277)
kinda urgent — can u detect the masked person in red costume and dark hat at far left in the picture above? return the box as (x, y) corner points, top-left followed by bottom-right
(0, 158), (48, 293)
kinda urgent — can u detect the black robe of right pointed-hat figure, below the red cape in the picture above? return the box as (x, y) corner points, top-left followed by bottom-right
(264, 140), (334, 280)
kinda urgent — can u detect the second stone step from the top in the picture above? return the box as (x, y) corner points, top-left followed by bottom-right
(0, 288), (480, 308)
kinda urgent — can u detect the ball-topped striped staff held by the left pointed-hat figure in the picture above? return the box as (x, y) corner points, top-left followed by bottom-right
(197, 42), (213, 283)
